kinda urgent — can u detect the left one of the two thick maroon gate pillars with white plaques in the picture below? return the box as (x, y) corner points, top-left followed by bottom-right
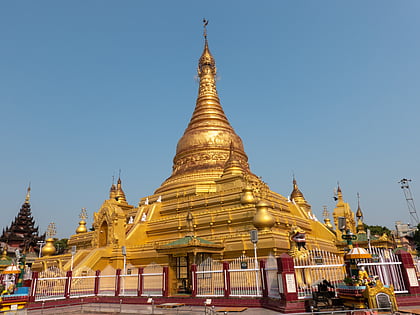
(277, 253), (305, 313)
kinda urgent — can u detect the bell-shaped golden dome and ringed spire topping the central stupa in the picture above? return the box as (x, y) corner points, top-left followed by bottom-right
(155, 29), (253, 193)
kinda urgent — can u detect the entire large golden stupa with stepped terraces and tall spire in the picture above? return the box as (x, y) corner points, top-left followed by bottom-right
(33, 24), (337, 294)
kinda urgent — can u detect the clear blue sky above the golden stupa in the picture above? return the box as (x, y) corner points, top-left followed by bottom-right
(0, 0), (420, 238)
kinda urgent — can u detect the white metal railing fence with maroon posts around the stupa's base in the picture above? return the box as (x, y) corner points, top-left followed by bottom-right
(31, 248), (419, 301)
